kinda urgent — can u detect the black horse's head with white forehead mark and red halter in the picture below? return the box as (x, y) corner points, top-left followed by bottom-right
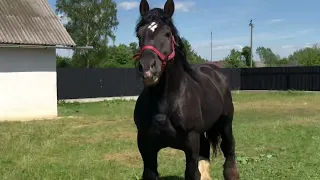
(136, 0), (176, 86)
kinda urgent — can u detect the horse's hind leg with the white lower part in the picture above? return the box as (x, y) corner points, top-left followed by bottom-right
(198, 133), (211, 180)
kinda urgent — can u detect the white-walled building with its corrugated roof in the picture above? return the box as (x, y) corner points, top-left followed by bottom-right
(0, 0), (75, 121)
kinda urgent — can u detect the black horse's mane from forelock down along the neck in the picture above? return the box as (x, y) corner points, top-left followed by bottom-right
(135, 8), (193, 73)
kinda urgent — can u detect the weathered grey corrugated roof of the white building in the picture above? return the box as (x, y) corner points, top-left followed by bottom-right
(0, 0), (75, 46)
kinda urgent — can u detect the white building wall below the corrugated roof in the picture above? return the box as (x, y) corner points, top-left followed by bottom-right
(0, 48), (57, 121)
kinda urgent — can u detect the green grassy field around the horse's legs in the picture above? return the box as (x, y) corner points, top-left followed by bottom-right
(0, 92), (320, 180)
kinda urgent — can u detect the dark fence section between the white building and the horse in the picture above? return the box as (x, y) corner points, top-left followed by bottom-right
(57, 68), (143, 99)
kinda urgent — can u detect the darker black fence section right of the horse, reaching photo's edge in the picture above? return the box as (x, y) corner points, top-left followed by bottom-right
(241, 66), (320, 91)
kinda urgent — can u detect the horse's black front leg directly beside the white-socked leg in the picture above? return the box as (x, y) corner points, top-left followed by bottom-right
(185, 132), (201, 180)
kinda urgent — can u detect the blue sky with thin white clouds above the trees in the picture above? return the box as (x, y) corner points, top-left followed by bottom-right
(49, 0), (320, 60)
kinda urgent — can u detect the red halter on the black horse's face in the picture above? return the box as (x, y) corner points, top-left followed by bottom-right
(133, 35), (176, 69)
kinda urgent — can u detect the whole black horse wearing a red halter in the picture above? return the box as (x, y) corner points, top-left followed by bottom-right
(134, 0), (239, 180)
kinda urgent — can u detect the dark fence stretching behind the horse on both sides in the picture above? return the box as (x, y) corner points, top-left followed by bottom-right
(57, 66), (320, 99)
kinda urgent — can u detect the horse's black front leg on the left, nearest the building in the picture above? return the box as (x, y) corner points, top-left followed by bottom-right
(137, 132), (160, 180)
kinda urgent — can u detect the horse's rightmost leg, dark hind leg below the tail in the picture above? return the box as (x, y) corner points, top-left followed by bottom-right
(219, 116), (240, 180)
